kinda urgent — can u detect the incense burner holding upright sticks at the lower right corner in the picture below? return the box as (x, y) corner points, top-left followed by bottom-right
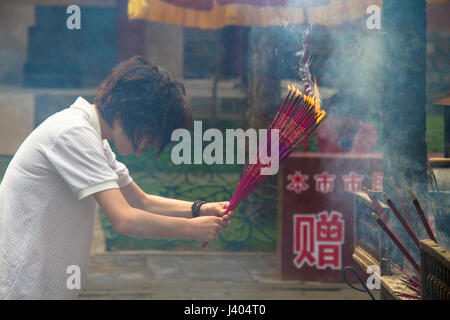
(353, 192), (450, 300)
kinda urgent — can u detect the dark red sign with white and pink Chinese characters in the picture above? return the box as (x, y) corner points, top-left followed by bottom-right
(278, 153), (383, 282)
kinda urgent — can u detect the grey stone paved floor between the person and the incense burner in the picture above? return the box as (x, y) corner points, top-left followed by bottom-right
(79, 212), (378, 300)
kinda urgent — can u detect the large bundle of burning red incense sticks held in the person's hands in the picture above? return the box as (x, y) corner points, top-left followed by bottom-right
(202, 79), (326, 247)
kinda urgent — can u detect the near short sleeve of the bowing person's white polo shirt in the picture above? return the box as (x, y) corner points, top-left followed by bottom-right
(45, 126), (119, 200)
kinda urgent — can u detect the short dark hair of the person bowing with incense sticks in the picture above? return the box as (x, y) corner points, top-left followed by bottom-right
(94, 56), (192, 156)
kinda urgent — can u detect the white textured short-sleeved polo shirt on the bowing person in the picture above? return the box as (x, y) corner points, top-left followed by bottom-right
(0, 97), (132, 299)
